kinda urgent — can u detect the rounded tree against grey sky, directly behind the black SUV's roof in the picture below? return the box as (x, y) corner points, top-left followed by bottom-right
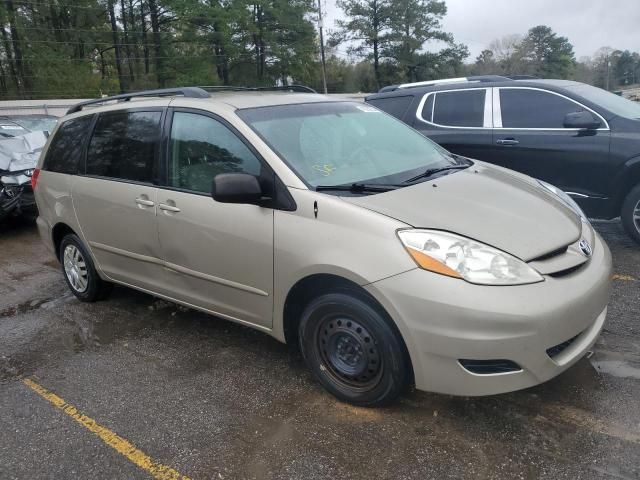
(514, 25), (576, 78)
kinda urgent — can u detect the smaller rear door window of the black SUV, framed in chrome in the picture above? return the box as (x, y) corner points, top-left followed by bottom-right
(424, 89), (486, 127)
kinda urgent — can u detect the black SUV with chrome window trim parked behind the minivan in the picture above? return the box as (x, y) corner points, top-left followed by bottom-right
(366, 76), (640, 243)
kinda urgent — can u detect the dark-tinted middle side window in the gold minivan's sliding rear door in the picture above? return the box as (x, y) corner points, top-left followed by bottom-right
(87, 112), (162, 183)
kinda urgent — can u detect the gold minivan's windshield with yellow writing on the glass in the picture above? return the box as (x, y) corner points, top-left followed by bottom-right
(238, 102), (460, 188)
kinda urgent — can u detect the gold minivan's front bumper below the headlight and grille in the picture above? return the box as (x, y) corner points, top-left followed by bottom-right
(365, 234), (611, 396)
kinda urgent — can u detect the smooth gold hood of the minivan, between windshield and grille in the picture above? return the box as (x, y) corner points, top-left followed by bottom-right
(342, 162), (582, 261)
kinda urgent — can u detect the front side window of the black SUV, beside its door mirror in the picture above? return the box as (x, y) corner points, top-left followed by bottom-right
(500, 88), (584, 128)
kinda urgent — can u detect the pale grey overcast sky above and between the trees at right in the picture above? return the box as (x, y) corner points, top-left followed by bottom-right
(324, 0), (640, 61)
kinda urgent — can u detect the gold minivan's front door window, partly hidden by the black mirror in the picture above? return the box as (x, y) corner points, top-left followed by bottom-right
(169, 112), (261, 193)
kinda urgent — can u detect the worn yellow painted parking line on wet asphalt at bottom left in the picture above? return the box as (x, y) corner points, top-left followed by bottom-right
(22, 378), (190, 480)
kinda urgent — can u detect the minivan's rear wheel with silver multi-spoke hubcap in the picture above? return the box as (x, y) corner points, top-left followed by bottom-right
(60, 234), (113, 302)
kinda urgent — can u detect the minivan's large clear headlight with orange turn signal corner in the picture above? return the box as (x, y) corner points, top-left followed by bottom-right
(398, 230), (544, 285)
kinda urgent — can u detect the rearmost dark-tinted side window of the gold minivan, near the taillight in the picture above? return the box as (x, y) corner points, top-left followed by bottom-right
(42, 115), (93, 174)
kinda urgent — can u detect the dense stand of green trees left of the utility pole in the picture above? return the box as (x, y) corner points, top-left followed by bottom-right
(0, 0), (319, 98)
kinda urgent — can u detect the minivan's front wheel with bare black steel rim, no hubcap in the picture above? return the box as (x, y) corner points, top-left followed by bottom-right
(298, 293), (411, 407)
